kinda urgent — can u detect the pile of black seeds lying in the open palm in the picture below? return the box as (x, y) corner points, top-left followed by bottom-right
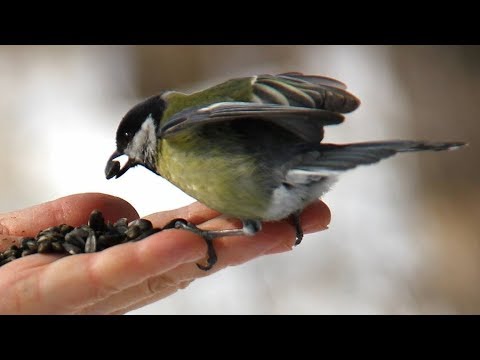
(0, 210), (161, 266)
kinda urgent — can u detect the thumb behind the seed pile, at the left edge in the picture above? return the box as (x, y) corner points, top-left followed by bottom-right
(0, 193), (138, 236)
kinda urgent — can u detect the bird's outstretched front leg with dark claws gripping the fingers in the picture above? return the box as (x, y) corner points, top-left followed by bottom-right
(162, 219), (262, 271)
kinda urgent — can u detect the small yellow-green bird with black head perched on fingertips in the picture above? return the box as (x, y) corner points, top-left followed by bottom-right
(105, 72), (465, 270)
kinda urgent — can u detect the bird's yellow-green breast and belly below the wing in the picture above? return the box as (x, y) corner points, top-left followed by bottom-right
(157, 132), (269, 219)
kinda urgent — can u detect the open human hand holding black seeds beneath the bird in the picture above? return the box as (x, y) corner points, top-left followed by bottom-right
(0, 193), (330, 314)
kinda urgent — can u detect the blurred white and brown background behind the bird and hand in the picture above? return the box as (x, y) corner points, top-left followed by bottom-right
(0, 46), (480, 314)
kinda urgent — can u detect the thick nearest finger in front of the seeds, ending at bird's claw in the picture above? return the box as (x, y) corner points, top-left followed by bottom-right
(0, 231), (204, 314)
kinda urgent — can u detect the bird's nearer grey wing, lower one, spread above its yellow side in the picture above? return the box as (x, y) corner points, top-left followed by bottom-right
(158, 102), (344, 142)
